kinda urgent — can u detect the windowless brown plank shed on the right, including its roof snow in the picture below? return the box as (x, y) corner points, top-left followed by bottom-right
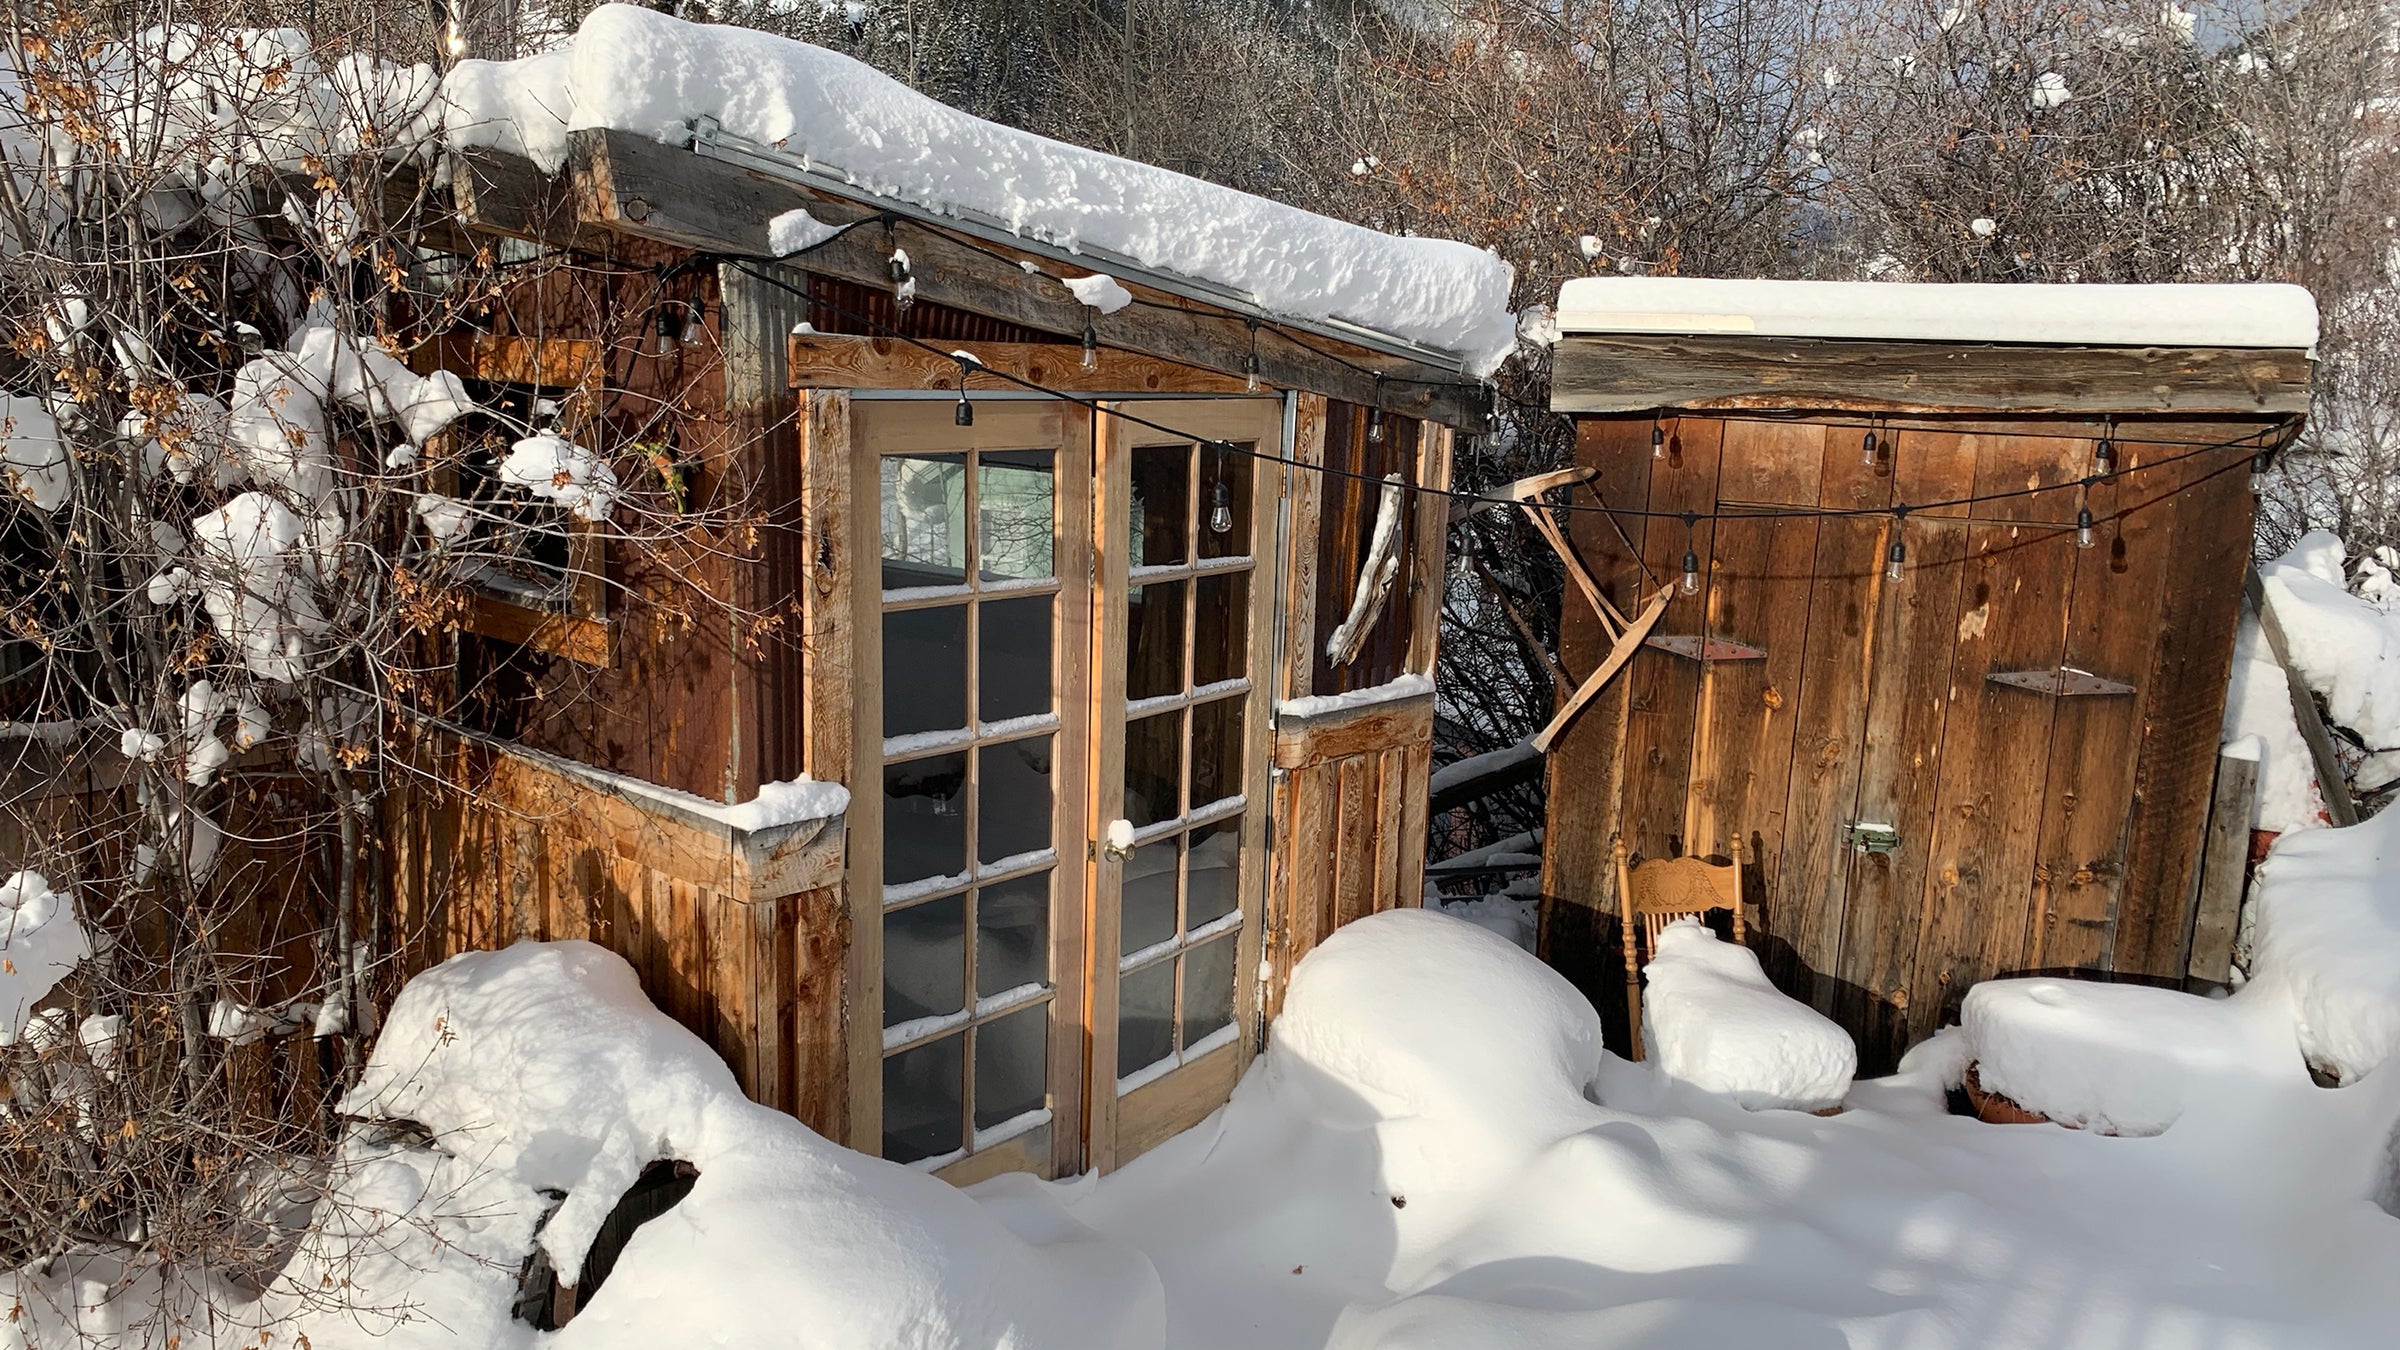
(1543, 279), (2316, 1069)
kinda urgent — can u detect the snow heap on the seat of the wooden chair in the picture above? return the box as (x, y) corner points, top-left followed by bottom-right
(1642, 920), (1858, 1110)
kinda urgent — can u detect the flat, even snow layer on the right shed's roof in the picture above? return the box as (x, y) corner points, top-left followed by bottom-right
(1558, 276), (2316, 348)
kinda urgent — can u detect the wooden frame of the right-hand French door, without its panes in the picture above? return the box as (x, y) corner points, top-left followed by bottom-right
(1085, 399), (1291, 1172)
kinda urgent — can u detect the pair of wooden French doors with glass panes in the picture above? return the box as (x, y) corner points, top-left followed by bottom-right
(850, 399), (1282, 1182)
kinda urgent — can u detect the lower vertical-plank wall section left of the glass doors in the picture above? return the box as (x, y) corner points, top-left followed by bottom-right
(386, 735), (850, 1139)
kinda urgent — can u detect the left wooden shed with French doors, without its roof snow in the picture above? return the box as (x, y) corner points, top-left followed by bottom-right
(391, 105), (1505, 1182)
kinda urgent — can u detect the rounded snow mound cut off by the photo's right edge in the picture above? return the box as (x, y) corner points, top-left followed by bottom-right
(2251, 810), (2400, 1083)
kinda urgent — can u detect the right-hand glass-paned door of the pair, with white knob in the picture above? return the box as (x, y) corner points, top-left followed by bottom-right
(1087, 399), (1284, 1170)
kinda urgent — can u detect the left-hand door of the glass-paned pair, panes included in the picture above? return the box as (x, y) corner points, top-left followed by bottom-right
(850, 399), (1092, 1182)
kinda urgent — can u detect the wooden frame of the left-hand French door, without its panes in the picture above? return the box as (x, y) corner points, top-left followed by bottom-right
(842, 392), (1094, 1184)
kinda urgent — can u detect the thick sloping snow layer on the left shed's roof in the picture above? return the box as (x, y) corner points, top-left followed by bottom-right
(444, 5), (1517, 372)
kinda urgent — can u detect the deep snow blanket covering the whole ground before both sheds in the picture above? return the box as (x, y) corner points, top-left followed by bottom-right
(14, 822), (2400, 1350)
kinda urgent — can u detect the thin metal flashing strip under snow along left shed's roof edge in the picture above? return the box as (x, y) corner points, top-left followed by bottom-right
(691, 118), (1481, 384)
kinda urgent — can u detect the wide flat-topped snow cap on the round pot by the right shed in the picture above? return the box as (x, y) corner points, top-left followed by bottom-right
(1958, 980), (2290, 1136)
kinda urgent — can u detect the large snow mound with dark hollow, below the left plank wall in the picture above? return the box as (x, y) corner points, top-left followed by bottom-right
(343, 942), (1164, 1350)
